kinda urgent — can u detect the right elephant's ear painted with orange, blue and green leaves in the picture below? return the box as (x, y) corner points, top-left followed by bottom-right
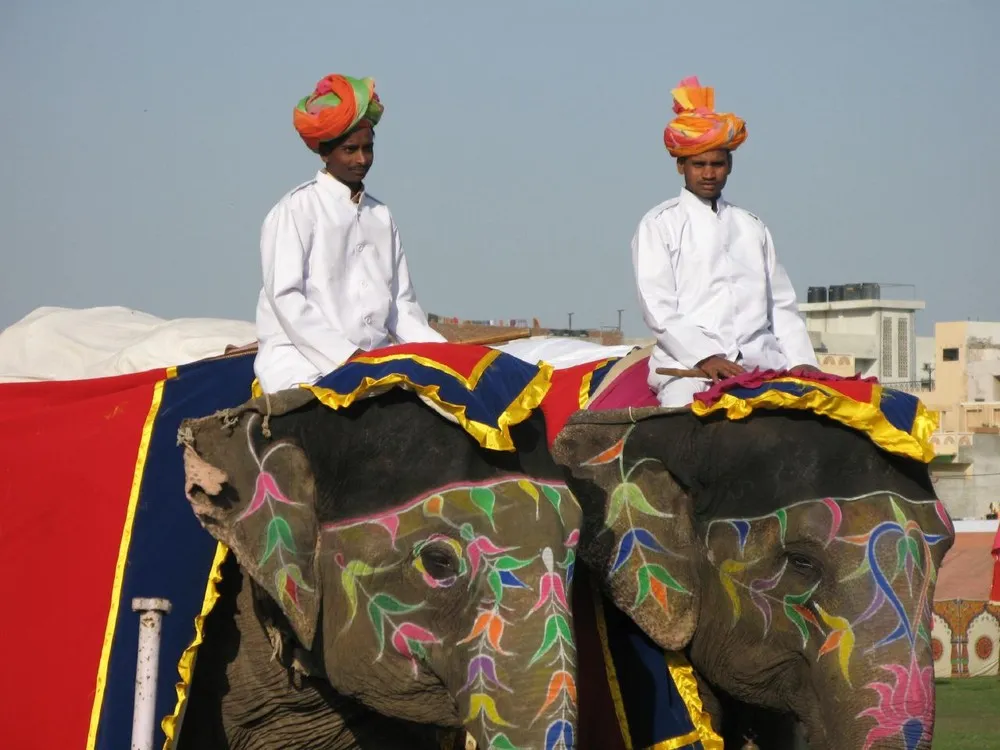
(553, 409), (700, 650)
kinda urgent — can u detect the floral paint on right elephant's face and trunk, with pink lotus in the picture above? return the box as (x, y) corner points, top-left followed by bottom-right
(705, 493), (951, 750)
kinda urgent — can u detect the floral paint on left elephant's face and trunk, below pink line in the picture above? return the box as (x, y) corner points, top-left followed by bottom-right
(323, 476), (580, 750)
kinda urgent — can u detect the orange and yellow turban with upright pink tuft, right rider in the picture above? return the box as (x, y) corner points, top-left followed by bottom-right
(663, 78), (747, 158)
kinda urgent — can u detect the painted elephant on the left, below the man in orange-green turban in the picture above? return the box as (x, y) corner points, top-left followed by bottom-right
(172, 390), (581, 750)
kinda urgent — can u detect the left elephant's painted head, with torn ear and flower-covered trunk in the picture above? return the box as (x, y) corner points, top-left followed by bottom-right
(182, 393), (581, 748)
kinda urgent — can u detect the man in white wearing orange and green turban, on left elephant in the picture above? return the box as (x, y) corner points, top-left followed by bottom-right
(254, 75), (445, 393)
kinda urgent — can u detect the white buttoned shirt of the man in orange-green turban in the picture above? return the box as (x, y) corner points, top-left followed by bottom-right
(254, 171), (445, 393)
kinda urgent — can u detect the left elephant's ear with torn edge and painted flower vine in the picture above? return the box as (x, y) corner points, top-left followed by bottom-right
(179, 390), (320, 650)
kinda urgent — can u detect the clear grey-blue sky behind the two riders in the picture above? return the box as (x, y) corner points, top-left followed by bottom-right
(0, 0), (1000, 335)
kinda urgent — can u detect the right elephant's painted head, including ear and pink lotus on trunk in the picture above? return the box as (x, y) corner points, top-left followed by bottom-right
(555, 410), (953, 750)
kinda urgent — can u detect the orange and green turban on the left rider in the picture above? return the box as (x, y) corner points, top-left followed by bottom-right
(292, 74), (385, 151)
